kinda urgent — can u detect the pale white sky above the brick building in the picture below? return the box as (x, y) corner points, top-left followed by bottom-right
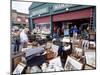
(12, 1), (32, 14)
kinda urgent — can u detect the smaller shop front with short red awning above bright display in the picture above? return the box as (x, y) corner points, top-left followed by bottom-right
(33, 16), (51, 34)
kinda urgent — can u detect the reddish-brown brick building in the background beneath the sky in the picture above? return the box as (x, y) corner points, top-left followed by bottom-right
(11, 10), (29, 28)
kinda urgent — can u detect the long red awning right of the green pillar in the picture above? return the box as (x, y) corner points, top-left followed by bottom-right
(53, 8), (92, 22)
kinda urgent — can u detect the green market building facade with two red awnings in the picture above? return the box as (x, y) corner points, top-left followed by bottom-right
(29, 2), (96, 33)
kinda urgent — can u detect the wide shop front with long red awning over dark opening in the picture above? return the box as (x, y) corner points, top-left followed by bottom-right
(53, 8), (93, 35)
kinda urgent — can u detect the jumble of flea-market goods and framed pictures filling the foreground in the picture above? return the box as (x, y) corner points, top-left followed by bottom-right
(12, 38), (96, 74)
